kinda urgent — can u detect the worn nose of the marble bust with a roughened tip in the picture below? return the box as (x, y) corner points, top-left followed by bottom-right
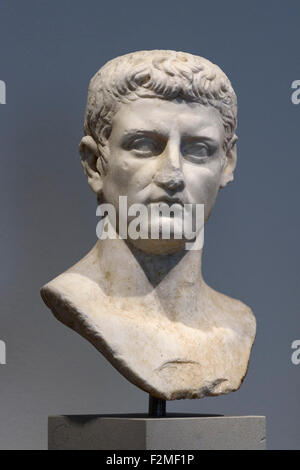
(154, 143), (185, 192)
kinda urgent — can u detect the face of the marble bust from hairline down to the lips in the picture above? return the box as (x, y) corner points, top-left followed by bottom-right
(103, 98), (226, 253)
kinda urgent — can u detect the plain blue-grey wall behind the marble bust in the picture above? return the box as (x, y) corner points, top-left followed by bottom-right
(0, 0), (300, 449)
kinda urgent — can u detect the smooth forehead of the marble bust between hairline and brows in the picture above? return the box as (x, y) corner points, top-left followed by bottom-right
(112, 98), (225, 140)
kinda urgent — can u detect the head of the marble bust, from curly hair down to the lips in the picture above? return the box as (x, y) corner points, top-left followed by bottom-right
(80, 50), (237, 253)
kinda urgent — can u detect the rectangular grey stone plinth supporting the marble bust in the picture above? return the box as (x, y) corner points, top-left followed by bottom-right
(48, 414), (266, 450)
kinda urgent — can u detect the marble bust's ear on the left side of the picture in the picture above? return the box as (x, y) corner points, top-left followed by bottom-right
(79, 135), (102, 197)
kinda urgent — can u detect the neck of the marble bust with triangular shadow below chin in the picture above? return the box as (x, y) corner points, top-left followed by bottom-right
(97, 238), (204, 318)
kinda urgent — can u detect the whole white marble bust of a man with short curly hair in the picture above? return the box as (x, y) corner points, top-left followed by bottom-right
(41, 50), (256, 400)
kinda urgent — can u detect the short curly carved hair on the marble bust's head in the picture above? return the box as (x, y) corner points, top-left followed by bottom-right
(84, 50), (237, 165)
